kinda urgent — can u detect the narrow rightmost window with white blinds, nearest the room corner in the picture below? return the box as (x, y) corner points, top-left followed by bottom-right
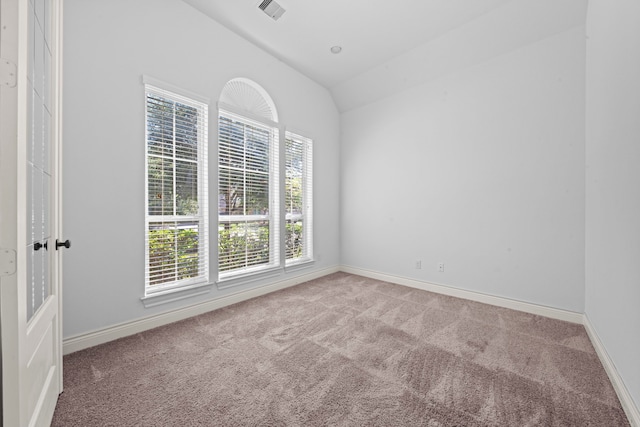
(285, 132), (313, 264)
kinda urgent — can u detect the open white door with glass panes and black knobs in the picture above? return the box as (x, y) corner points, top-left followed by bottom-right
(0, 0), (64, 426)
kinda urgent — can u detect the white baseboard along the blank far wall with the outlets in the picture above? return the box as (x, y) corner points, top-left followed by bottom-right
(340, 265), (582, 323)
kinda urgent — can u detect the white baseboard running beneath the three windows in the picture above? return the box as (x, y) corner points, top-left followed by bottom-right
(62, 266), (340, 354)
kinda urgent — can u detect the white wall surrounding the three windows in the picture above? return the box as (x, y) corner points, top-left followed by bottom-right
(63, 0), (339, 337)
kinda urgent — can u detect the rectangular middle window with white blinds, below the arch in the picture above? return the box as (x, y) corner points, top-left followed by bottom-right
(218, 109), (280, 279)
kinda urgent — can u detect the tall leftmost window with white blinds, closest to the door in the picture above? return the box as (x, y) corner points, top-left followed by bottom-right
(145, 84), (209, 294)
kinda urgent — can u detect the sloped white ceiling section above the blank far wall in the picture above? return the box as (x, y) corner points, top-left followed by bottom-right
(331, 0), (587, 112)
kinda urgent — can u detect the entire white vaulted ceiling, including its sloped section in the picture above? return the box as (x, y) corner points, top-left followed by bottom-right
(183, 0), (587, 111)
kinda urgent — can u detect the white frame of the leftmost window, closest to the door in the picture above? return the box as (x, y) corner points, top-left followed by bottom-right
(142, 76), (210, 298)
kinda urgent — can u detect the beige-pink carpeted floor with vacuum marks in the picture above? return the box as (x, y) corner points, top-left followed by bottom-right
(53, 273), (629, 427)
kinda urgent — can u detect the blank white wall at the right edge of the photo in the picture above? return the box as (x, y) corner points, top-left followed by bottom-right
(586, 0), (640, 407)
